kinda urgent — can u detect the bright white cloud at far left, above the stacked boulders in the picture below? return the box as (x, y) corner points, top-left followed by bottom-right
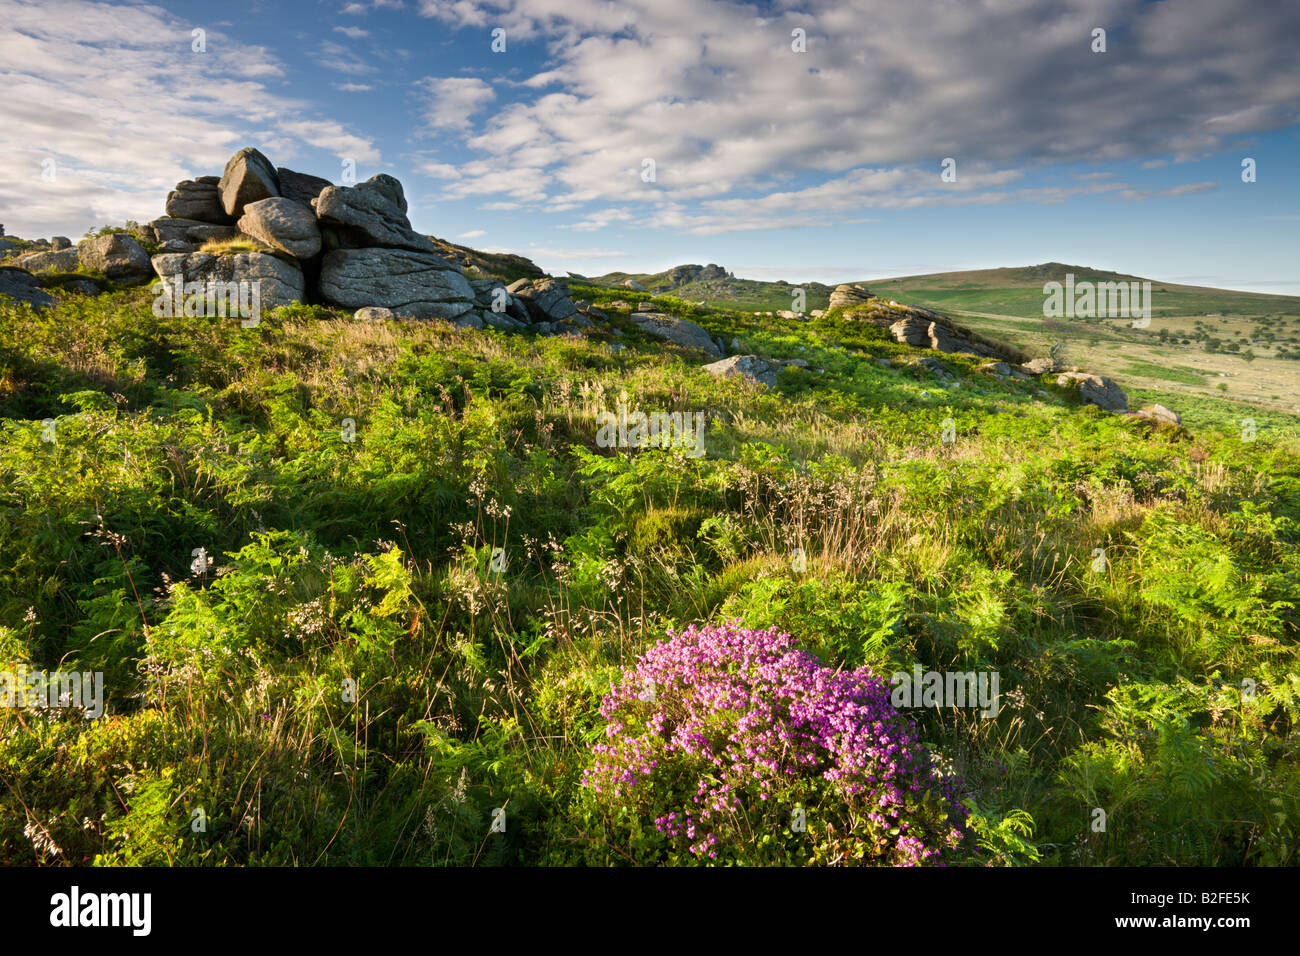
(0, 0), (378, 237)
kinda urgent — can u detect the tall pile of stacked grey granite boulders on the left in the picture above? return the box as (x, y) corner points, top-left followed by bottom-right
(148, 148), (590, 333)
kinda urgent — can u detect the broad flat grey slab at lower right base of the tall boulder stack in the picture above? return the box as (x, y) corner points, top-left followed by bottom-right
(320, 248), (475, 319)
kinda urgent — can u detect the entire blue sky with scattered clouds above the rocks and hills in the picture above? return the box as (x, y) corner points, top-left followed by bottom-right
(0, 0), (1300, 294)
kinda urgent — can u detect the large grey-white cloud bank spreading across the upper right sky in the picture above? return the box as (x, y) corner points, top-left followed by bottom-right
(420, 0), (1300, 230)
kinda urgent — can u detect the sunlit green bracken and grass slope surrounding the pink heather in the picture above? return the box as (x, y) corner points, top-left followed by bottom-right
(0, 286), (1300, 865)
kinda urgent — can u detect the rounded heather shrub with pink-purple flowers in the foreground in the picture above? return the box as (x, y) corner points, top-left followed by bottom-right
(582, 624), (970, 865)
